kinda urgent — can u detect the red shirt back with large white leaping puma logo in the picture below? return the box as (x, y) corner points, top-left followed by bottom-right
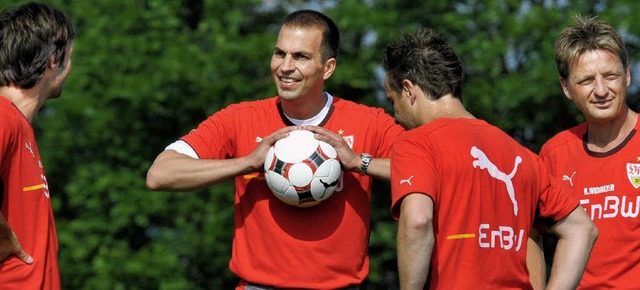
(391, 118), (578, 289)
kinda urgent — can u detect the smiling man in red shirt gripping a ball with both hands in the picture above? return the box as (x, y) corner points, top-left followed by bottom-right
(147, 10), (403, 289)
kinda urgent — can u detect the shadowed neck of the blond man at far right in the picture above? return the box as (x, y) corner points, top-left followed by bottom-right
(587, 108), (638, 152)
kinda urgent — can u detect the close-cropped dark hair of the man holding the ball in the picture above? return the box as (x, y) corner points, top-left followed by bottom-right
(282, 10), (340, 61)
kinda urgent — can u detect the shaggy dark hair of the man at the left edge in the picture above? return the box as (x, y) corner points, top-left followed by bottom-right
(0, 2), (76, 89)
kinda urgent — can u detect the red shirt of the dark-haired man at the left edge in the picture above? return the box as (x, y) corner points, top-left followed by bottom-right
(0, 96), (60, 290)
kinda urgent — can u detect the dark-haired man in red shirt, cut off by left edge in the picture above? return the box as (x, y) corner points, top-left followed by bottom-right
(0, 3), (75, 289)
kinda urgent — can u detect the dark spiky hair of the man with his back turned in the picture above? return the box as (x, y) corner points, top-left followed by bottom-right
(383, 28), (464, 100)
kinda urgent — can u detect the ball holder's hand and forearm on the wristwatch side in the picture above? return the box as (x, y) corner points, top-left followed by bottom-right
(302, 126), (391, 181)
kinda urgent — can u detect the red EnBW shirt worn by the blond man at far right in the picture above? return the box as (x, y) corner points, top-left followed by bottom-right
(540, 118), (640, 289)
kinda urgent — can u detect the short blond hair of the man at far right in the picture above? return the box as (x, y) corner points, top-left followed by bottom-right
(555, 15), (629, 79)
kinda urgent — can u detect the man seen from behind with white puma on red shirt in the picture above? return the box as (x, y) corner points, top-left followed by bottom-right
(384, 29), (597, 289)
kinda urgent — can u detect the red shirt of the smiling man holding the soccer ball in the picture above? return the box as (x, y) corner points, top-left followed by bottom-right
(181, 97), (403, 289)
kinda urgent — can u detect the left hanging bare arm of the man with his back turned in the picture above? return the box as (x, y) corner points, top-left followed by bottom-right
(397, 193), (435, 290)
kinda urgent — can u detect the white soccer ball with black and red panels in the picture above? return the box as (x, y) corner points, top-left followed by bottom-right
(264, 130), (342, 207)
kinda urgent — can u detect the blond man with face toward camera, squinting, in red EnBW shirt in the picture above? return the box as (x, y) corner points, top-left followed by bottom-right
(533, 17), (640, 289)
